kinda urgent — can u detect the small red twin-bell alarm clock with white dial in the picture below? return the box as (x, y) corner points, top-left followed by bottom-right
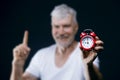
(80, 29), (96, 51)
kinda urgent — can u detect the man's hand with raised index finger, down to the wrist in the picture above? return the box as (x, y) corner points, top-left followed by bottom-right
(13, 31), (30, 66)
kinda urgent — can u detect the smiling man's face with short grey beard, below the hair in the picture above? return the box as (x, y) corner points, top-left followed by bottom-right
(52, 15), (78, 47)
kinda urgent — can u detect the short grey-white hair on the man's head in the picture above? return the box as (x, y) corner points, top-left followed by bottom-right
(51, 4), (77, 23)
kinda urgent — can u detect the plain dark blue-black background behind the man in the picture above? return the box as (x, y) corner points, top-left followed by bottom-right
(0, 0), (120, 80)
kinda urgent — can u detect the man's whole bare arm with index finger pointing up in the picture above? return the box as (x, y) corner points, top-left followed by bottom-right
(10, 31), (37, 80)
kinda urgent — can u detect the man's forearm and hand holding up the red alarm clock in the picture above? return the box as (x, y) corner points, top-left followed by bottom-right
(83, 37), (103, 80)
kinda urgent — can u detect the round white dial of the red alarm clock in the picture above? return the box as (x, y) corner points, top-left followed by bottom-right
(81, 36), (94, 49)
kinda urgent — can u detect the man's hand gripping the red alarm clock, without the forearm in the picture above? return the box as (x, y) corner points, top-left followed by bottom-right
(83, 36), (103, 64)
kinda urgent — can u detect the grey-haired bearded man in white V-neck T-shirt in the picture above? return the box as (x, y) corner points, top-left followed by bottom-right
(10, 4), (103, 80)
